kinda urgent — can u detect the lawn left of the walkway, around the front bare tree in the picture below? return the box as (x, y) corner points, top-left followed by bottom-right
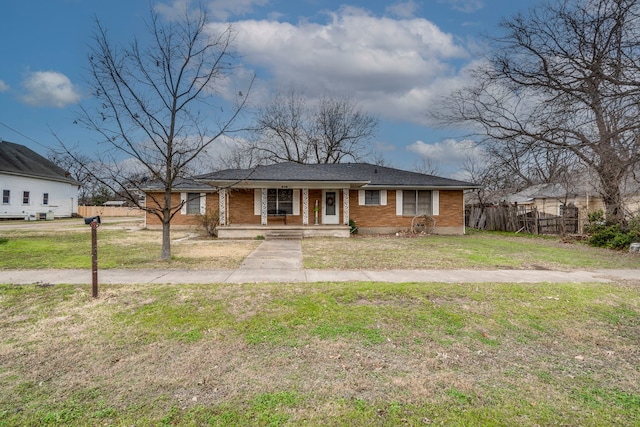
(0, 226), (260, 269)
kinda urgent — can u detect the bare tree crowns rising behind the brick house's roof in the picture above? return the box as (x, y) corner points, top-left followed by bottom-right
(251, 87), (378, 163)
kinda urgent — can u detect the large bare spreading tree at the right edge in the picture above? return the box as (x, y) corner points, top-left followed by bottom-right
(434, 0), (640, 229)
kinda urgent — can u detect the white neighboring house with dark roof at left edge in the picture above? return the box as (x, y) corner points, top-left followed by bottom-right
(0, 140), (80, 219)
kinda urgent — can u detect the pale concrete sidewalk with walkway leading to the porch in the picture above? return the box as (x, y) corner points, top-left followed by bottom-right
(0, 240), (640, 285)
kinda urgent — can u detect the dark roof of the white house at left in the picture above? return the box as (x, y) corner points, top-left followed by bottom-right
(0, 141), (79, 184)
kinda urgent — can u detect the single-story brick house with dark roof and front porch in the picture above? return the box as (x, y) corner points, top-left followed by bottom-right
(142, 163), (478, 238)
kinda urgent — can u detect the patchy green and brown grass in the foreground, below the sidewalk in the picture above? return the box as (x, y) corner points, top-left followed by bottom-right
(0, 282), (640, 427)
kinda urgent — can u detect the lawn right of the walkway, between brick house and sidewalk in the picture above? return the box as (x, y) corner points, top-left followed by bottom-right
(303, 231), (640, 270)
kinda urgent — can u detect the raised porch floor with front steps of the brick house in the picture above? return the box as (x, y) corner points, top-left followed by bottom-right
(217, 224), (351, 239)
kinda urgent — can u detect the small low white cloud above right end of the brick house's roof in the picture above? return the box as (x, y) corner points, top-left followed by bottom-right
(407, 139), (483, 169)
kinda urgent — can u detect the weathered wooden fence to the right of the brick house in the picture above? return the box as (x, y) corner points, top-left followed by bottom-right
(466, 204), (579, 234)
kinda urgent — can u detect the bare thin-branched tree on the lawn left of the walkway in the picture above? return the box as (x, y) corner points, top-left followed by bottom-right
(60, 7), (251, 259)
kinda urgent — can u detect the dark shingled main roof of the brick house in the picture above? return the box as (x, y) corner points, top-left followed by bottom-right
(195, 162), (478, 188)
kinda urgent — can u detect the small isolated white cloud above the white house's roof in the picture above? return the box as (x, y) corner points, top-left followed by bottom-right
(21, 71), (80, 108)
